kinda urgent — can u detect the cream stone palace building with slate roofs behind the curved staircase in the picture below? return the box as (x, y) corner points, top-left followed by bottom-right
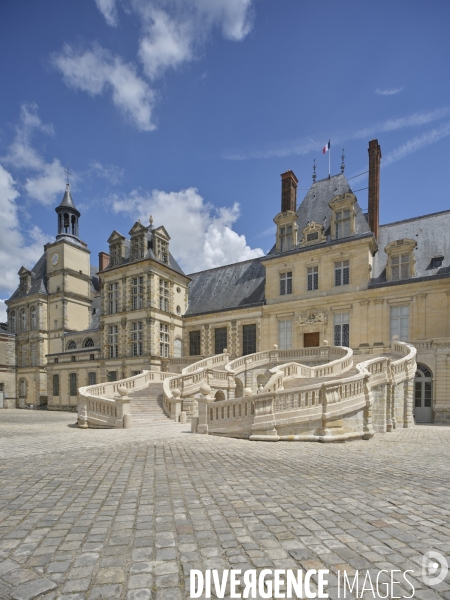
(0, 140), (450, 423)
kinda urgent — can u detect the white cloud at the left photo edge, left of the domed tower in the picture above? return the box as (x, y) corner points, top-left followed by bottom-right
(0, 165), (50, 321)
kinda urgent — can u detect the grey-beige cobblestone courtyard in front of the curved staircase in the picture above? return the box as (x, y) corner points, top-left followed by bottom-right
(0, 410), (450, 600)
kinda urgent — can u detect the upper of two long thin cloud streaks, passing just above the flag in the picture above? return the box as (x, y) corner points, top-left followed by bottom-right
(222, 106), (450, 160)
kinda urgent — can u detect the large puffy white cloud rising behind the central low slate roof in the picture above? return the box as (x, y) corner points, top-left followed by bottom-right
(110, 188), (264, 273)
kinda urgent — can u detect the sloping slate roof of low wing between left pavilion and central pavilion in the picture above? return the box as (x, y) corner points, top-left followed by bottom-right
(185, 258), (266, 316)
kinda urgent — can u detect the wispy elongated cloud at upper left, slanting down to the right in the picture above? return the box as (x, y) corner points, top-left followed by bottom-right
(52, 44), (155, 131)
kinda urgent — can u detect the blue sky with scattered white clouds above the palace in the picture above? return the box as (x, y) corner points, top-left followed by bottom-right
(0, 0), (450, 321)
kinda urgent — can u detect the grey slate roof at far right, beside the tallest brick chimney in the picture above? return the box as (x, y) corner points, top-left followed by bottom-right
(371, 210), (450, 284)
